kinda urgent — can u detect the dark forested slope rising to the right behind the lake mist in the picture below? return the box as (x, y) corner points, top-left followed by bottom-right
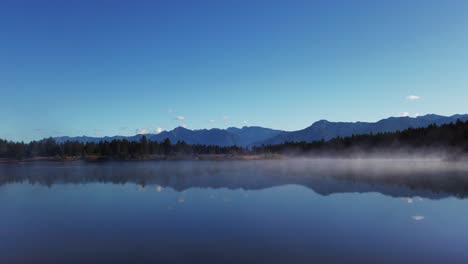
(252, 120), (468, 156)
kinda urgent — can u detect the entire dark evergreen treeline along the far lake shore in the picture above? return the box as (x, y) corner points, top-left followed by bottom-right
(0, 121), (468, 160)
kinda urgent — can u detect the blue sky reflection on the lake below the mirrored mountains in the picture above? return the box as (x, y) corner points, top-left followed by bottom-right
(0, 183), (468, 263)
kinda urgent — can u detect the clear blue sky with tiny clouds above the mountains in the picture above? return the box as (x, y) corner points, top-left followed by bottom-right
(0, 0), (468, 141)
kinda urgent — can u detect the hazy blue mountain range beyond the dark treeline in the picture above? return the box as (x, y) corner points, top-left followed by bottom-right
(55, 114), (468, 147)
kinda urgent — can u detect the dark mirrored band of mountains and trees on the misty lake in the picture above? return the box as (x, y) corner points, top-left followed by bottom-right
(0, 159), (468, 199)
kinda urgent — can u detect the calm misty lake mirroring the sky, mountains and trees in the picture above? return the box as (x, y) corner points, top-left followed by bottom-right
(0, 159), (468, 264)
